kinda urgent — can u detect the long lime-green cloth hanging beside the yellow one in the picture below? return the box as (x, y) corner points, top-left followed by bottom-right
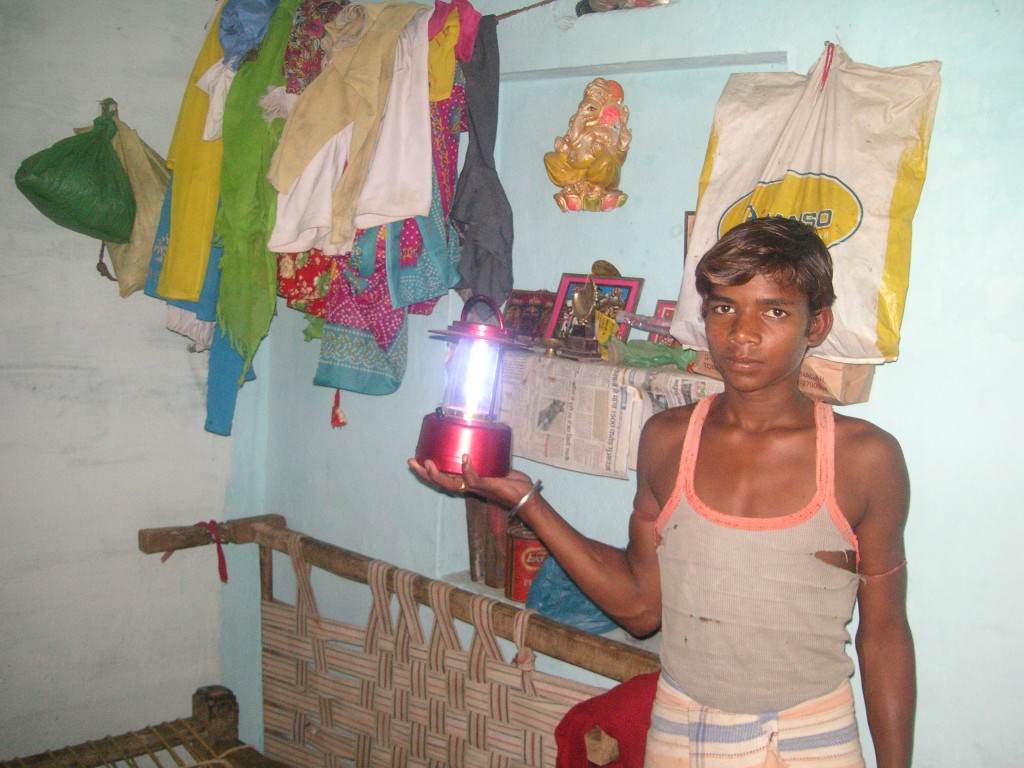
(217, 0), (300, 376)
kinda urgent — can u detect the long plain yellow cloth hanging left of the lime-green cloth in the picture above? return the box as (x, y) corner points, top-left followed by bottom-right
(157, 11), (224, 301)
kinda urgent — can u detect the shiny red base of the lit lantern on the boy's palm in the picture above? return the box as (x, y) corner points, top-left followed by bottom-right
(416, 409), (512, 477)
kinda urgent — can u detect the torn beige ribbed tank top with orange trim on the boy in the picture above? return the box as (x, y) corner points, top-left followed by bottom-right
(655, 397), (860, 714)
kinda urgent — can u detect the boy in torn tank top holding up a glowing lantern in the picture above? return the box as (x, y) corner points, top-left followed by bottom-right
(410, 218), (915, 768)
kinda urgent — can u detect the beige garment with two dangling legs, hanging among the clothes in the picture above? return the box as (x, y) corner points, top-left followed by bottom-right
(267, 3), (429, 252)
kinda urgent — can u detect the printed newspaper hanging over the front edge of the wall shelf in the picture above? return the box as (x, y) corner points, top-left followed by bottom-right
(501, 351), (722, 479)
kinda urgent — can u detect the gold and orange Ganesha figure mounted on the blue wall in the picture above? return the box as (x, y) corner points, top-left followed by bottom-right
(544, 78), (633, 211)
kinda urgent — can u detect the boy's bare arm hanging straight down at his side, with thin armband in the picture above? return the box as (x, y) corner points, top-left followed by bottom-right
(855, 430), (916, 768)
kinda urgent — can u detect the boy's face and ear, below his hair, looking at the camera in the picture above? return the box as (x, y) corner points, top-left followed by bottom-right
(703, 274), (833, 391)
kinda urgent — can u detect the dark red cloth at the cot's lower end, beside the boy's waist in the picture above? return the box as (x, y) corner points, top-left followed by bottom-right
(555, 672), (660, 768)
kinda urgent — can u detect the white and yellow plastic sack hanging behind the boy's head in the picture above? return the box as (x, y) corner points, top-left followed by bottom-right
(671, 43), (941, 364)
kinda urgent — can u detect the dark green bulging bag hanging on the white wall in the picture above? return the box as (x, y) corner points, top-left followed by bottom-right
(14, 99), (135, 243)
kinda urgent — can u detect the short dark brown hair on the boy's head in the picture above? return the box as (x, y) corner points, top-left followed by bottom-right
(696, 218), (836, 315)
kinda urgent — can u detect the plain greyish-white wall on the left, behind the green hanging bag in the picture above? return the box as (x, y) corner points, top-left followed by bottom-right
(0, 0), (231, 759)
